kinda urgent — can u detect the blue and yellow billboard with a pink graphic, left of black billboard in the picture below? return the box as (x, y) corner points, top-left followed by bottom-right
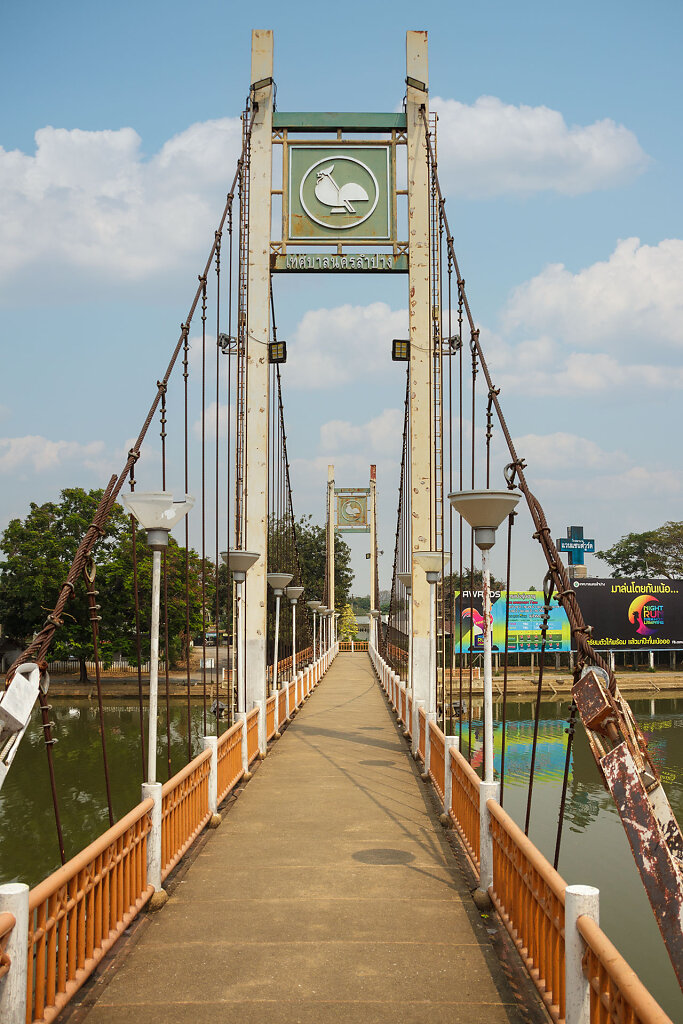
(453, 590), (571, 654)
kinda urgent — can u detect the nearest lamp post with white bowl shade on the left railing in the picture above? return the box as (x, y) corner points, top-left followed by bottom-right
(121, 490), (195, 782)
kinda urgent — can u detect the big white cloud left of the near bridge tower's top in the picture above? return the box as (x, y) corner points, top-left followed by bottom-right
(0, 118), (241, 290)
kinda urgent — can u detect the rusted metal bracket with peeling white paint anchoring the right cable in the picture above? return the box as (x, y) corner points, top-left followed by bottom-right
(571, 668), (683, 987)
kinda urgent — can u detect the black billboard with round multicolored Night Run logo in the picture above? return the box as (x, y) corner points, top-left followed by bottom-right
(572, 580), (683, 650)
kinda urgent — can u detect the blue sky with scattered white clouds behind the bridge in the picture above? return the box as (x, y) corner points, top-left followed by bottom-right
(0, 0), (683, 591)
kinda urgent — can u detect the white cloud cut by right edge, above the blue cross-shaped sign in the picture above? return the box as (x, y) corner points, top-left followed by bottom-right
(503, 239), (683, 352)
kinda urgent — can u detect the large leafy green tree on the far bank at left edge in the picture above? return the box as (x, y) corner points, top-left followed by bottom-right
(0, 487), (208, 680)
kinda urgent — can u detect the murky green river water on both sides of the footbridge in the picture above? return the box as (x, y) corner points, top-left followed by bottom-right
(0, 698), (683, 1021)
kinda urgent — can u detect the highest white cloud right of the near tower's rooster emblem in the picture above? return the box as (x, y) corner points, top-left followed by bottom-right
(431, 96), (648, 197)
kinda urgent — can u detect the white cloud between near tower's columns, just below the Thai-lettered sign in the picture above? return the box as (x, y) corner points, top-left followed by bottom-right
(288, 302), (408, 389)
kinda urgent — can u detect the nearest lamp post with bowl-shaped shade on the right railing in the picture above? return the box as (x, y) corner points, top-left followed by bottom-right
(449, 490), (521, 782)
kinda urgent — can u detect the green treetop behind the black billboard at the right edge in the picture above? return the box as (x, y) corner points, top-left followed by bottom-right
(596, 522), (683, 580)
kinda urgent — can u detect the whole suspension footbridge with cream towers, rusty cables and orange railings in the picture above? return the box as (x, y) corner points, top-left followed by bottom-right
(0, 31), (683, 1024)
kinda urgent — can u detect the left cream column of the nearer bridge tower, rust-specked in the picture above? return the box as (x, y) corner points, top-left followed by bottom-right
(245, 30), (272, 729)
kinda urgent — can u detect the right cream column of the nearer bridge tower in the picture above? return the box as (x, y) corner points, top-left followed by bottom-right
(405, 32), (436, 720)
